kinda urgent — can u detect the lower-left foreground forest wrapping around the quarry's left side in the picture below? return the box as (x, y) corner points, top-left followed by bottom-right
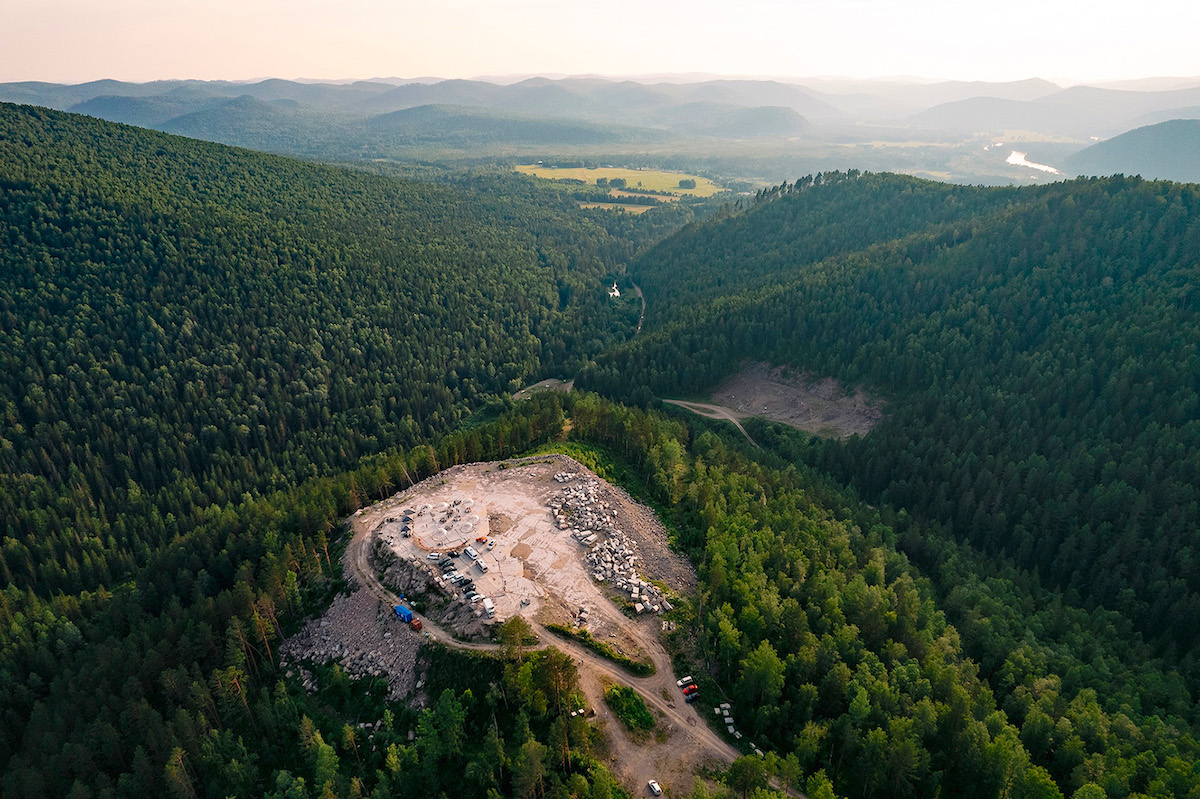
(0, 397), (597, 799)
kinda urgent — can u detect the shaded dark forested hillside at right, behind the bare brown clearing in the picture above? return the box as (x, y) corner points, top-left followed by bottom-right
(581, 175), (1200, 692)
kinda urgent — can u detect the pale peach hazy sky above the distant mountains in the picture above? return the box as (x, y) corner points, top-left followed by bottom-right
(0, 0), (1200, 83)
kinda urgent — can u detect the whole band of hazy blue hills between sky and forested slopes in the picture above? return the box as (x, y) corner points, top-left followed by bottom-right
(7, 74), (1200, 185)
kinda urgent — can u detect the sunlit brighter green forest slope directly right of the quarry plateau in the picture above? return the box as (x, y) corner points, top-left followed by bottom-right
(570, 397), (1200, 798)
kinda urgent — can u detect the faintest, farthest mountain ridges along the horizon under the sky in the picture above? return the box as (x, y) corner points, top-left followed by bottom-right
(9, 76), (1200, 137)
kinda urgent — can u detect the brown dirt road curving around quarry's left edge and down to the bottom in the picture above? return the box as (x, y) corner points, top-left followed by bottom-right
(346, 460), (740, 795)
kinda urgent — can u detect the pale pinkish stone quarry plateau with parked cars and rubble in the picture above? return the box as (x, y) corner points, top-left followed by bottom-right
(360, 455), (696, 636)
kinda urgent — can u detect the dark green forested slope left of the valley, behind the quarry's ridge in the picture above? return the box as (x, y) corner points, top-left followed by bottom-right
(0, 99), (657, 596)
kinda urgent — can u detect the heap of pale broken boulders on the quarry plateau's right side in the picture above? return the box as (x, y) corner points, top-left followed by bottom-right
(548, 471), (671, 613)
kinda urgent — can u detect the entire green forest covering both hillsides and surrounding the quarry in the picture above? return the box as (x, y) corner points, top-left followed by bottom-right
(0, 106), (1200, 799)
